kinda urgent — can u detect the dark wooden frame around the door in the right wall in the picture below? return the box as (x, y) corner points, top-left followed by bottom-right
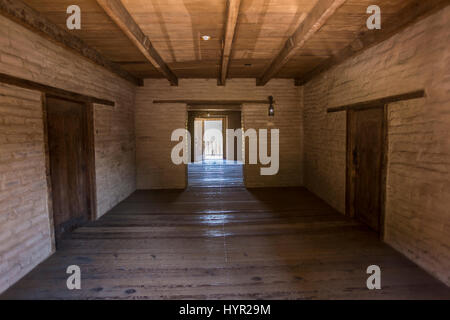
(345, 104), (389, 240)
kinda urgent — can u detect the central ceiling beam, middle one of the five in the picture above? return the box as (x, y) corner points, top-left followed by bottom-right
(218, 0), (241, 86)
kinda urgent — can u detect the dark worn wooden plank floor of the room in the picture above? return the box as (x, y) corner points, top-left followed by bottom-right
(1, 167), (450, 299)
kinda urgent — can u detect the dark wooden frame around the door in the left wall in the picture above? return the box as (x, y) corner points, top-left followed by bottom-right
(41, 93), (97, 252)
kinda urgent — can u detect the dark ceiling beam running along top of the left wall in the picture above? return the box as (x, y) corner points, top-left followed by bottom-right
(0, 0), (143, 86)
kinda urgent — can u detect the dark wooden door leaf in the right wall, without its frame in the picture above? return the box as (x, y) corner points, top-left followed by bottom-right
(353, 107), (384, 232)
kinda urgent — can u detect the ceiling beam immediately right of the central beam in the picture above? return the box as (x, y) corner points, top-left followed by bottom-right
(256, 0), (346, 86)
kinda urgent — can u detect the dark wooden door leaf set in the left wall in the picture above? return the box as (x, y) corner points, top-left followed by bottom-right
(47, 97), (90, 244)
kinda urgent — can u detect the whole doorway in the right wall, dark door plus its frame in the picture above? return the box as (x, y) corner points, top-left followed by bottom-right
(346, 105), (387, 237)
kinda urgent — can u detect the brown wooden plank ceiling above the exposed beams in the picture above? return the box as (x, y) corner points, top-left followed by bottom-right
(17, 0), (446, 84)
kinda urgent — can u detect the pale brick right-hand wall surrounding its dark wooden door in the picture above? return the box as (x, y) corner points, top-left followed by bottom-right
(304, 7), (450, 284)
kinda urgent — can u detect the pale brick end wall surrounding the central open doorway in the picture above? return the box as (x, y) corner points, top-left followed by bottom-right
(136, 79), (303, 189)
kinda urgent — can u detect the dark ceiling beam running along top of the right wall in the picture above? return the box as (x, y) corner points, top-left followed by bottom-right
(295, 0), (450, 86)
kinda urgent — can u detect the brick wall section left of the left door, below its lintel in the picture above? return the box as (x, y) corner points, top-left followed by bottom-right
(0, 84), (52, 293)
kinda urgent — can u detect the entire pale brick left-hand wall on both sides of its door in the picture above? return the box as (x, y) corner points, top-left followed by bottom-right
(0, 16), (135, 292)
